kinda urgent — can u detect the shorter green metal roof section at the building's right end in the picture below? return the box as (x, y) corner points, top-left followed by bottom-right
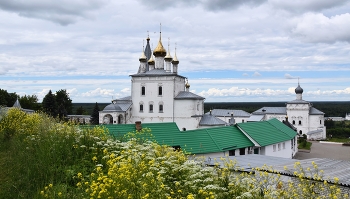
(237, 118), (296, 146)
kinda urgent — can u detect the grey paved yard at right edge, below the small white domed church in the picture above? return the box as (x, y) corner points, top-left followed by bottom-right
(294, 141), (350, 161)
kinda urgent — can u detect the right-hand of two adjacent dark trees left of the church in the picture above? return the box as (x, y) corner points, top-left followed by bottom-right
(56, 89), (73, 118)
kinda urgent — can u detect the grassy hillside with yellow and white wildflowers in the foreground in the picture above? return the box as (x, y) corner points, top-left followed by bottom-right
(0, 108), (349, 199)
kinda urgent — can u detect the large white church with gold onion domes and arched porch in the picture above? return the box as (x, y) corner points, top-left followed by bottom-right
(99, 32), (205, 130)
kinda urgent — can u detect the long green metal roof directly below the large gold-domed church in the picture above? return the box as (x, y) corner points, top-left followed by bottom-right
(104, 123), (254, 154)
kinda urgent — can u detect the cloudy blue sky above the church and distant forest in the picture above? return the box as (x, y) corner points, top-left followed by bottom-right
(0, 0), (350, 103)
